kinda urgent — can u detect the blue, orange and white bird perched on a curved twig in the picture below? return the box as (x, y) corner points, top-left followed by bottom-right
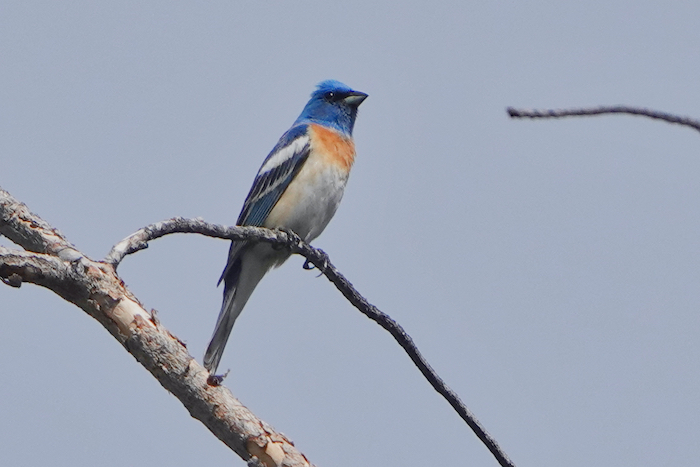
(204, 80), (368, 376)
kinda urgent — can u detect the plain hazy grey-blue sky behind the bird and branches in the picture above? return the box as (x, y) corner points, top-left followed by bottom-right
(0, 0), (700, 467)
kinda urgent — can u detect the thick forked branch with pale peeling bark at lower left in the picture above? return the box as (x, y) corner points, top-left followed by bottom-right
(0, 189), (311, 467)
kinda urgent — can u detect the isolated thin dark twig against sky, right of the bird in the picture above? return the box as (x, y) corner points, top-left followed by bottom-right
(506, 105), (700, 131)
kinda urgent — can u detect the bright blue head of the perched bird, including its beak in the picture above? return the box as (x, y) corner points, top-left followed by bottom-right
(297, 79), (367, 136)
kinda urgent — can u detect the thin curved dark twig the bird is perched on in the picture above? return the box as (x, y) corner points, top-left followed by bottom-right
(105, 217), (514, 467)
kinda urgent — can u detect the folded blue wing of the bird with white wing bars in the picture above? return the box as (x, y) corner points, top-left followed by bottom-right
(237, 125), (310, 227)
